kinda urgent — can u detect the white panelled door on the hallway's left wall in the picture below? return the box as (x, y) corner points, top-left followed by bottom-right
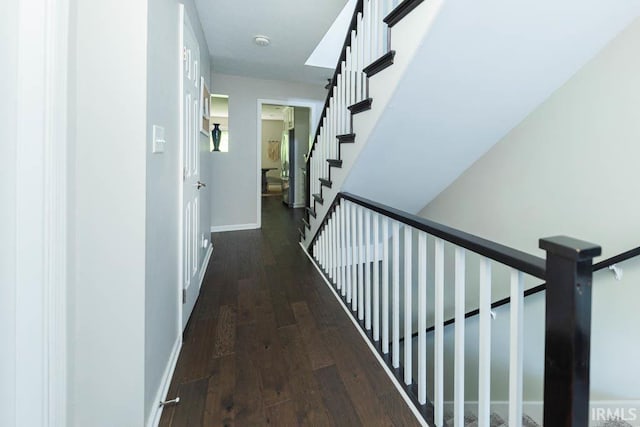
(181, 14), (203, 330)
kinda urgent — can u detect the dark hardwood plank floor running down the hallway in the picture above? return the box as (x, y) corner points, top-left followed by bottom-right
(160, 197), (418, 427)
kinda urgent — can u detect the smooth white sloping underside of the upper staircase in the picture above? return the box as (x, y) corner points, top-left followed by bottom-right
(342, 0), (640, 214)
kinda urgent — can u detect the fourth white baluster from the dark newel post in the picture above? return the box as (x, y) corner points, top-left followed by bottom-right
(433, 239), (444, 425)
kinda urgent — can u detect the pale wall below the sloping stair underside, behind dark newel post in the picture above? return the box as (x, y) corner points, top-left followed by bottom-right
(420, 20), (640, 399)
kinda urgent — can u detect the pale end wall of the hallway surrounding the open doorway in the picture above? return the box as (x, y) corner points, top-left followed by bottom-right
(211, 74), (326, 227)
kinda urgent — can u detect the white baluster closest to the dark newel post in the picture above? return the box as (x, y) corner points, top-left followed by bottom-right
(509, 269), (524, 426)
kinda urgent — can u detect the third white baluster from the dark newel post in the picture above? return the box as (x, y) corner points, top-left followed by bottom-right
(453, 247), (465, 427)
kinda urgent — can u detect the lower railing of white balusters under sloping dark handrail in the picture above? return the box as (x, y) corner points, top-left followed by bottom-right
(310, 193), (599, 427)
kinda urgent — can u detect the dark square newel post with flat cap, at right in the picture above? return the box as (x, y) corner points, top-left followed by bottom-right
(540, 236), (602, 427)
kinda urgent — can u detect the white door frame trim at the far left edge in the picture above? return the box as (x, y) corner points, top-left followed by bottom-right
(9, 0), (73, 427)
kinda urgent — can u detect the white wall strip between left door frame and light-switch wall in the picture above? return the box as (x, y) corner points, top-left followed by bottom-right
(69, 0), (147, 427)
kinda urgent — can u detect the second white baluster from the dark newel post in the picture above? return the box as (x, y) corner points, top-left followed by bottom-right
(478, 258), (491, 426)
